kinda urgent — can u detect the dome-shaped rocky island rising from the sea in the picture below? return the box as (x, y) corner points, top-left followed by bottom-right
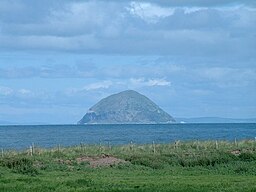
(78, 90), (175, 124)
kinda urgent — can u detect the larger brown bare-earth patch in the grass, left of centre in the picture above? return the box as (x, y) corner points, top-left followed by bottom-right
(76, 154), (127, 168)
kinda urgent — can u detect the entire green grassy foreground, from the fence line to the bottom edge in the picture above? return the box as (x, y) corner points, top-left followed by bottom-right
(0, 140), (256, 192)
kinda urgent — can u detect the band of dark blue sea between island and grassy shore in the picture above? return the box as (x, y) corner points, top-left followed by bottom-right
(0, 123), (256, 149)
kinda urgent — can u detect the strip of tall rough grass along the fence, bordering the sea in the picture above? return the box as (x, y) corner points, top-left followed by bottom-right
(0, 140), (256, 172)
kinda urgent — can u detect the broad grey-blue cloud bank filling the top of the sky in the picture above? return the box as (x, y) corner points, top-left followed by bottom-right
(0, 1), (256, 58)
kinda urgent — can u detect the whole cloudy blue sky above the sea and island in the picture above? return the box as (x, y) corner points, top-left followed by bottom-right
(0, 0), (256, 124)
